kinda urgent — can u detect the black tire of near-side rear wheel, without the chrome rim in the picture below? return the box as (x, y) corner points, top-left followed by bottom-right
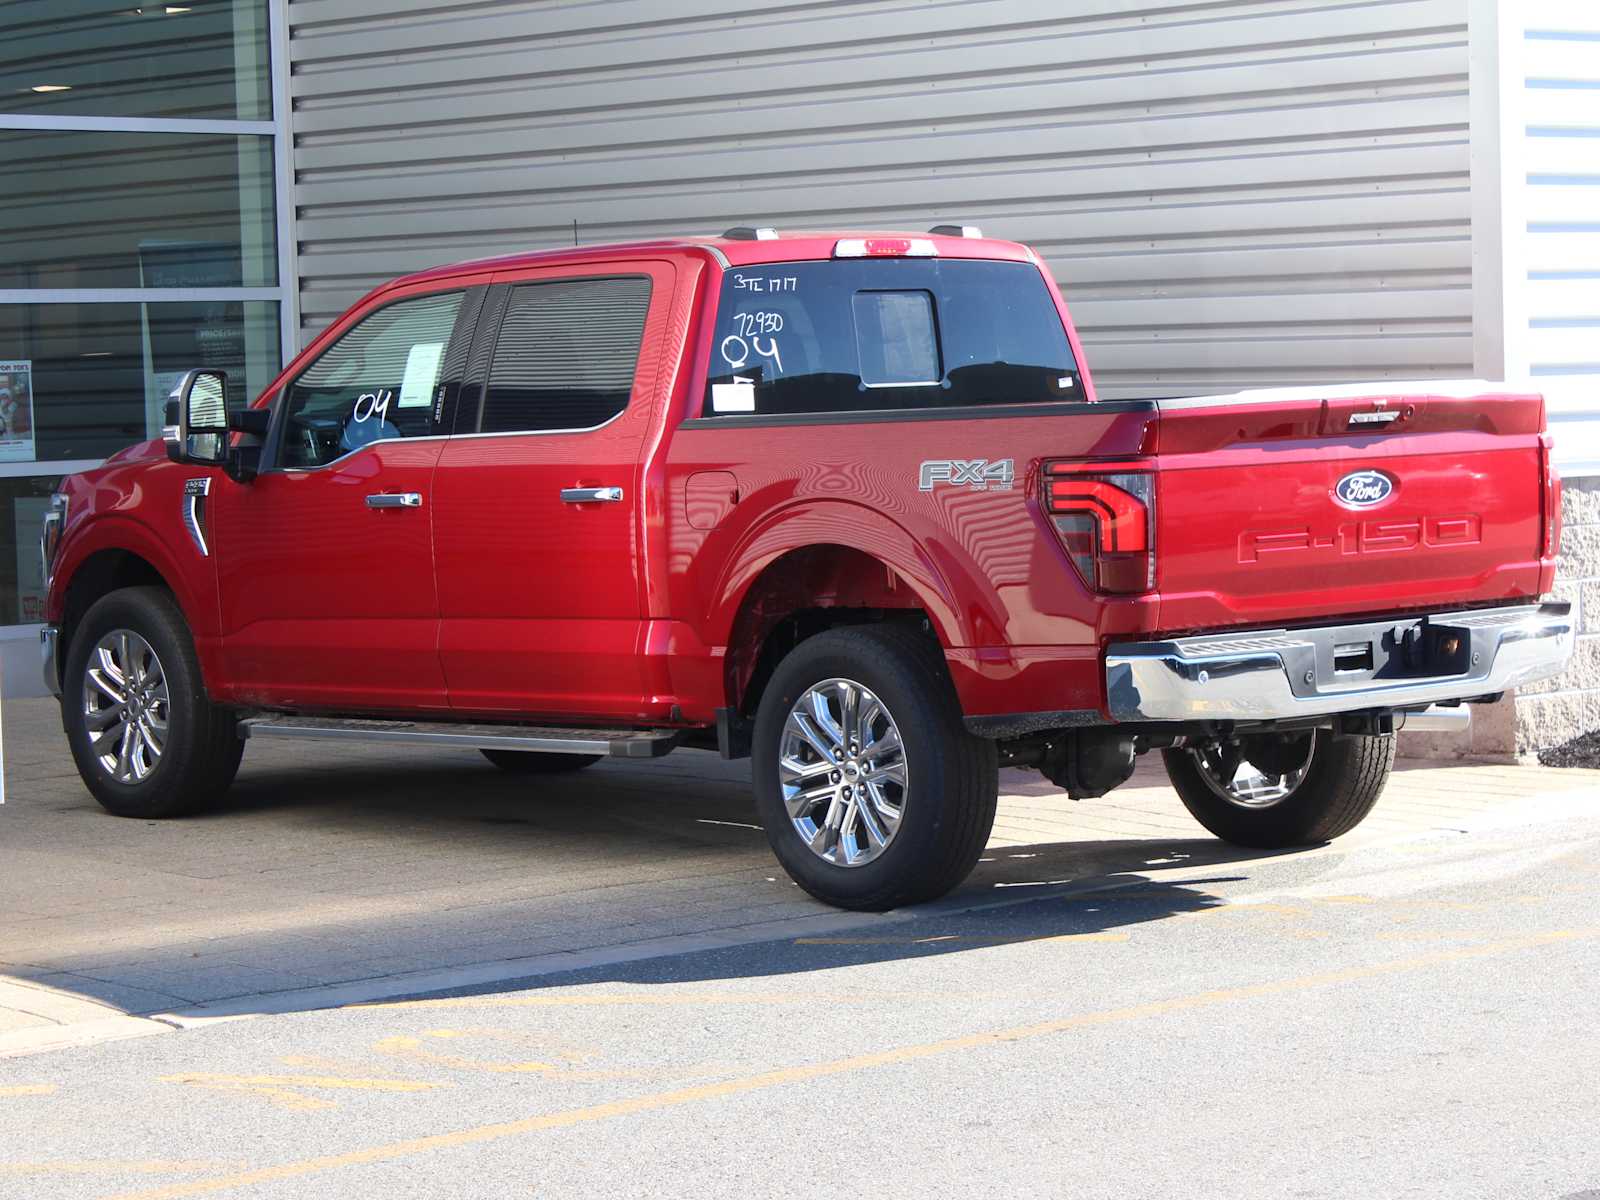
(750, 626), (1000, 912)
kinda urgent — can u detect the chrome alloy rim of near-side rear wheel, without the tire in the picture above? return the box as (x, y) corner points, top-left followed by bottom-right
(778, 678), (909, 867)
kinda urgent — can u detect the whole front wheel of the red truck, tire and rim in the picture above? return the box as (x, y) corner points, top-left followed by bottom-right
(61, 587), (245, 818)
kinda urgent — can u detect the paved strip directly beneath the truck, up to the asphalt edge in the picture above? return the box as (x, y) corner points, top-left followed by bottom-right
(0, 701), (1600, 1053)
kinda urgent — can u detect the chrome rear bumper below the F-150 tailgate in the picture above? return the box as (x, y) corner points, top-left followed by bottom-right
(1106, 603), (1576, 722)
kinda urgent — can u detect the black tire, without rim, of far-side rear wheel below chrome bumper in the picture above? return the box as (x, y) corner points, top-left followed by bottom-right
(1162, 730), (1395, 850)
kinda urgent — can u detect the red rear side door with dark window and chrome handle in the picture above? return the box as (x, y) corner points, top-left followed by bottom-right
(434, 261), (674, 720)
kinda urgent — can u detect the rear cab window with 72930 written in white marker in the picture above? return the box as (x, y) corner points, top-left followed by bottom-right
(701, 259), (1083, 418)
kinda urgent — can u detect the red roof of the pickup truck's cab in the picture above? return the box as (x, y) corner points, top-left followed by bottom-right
(389, 229), (1035, 286)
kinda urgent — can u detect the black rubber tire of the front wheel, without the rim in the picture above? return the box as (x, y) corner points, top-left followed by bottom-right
(61, 587), (245, 818)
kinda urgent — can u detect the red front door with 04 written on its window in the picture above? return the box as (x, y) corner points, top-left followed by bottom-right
(213, 285), (485, 712)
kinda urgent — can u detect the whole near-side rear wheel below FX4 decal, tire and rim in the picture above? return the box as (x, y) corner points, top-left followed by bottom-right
(752, 626), (998, 910)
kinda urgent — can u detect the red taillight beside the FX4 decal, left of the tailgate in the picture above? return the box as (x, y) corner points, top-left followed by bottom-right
(1043, 462), (1155, 594)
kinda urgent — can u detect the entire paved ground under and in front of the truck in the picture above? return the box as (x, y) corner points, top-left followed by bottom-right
(0, 701), (1600, 1200)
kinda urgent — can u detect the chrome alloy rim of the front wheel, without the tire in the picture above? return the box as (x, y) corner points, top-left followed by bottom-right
(83, 629), (171, 784)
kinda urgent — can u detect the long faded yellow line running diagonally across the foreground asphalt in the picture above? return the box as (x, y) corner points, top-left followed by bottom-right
(106, 928), (1600, 1200)
